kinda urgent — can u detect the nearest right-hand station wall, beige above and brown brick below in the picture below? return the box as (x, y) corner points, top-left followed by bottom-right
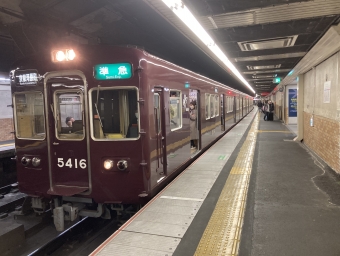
(303, 52), (340, 173)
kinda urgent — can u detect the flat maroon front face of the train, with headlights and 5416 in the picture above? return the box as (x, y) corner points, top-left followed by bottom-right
(11, 48), (146, 230)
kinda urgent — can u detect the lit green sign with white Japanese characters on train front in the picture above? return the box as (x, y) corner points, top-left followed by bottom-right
(94, 63), (132, 80)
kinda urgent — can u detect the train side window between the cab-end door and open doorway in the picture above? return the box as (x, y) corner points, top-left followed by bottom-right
(169, 90), (182, 131)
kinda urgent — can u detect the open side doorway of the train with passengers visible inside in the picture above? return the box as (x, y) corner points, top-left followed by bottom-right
(189, 89), (201, 154)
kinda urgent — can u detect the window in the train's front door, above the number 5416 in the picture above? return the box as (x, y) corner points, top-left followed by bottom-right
(53, 91), (84, 140)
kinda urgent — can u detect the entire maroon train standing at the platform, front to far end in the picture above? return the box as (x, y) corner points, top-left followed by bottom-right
(10, 46), (253, 230)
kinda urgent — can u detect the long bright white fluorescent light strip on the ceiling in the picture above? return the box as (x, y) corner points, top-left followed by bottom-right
(162, 0), (255, 93)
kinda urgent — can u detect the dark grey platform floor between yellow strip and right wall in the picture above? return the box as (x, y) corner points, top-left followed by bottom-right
(239, 114), (340, 256)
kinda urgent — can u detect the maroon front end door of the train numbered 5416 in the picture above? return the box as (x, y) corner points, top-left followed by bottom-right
(44, 71), (90, 196)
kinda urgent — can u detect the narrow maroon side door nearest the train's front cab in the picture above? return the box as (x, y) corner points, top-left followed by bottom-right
(154, 87), (167, 176)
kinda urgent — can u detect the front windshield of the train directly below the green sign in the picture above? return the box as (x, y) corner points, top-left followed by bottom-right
(91, 87), (139, 140)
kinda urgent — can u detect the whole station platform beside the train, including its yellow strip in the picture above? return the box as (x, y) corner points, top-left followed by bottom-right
(90, 109), (340, 256)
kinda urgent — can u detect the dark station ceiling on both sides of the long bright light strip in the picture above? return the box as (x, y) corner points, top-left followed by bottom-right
(0, 0), (340, 93)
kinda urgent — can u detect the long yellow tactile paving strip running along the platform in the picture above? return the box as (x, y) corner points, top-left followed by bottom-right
(195, 115), (259, 256)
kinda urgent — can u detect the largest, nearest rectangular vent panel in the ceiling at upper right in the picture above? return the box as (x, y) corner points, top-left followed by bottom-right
(238, 35), (298, 51)
